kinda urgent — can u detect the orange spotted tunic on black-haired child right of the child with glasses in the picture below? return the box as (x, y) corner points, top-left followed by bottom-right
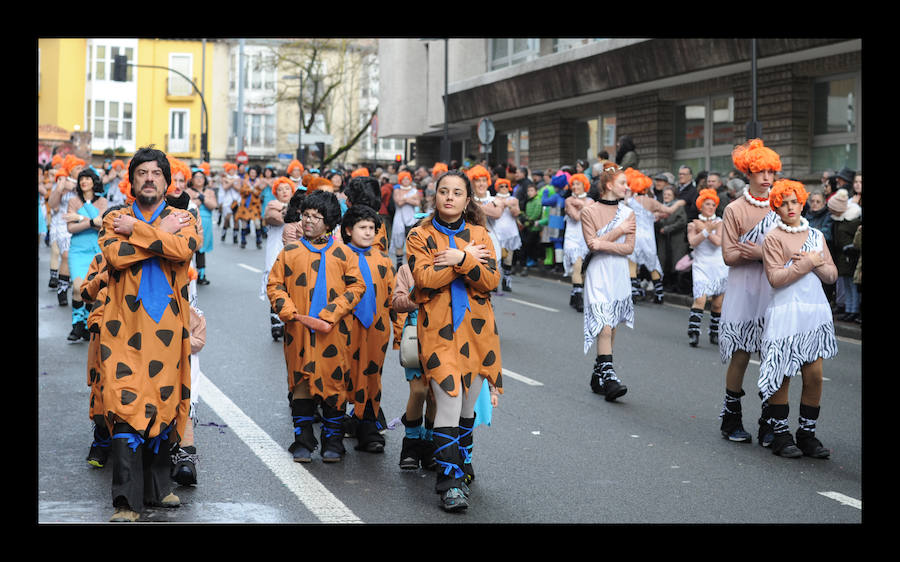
(347, 246), (394, 419)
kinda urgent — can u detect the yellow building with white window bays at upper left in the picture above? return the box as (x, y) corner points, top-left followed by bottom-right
(38, 38), (215, 161)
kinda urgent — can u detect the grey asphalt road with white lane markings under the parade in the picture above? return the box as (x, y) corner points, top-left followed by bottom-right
(36, 230), (862, 524)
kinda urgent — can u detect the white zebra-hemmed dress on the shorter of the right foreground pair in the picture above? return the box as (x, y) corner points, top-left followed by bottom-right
(757, 228), (837, 400)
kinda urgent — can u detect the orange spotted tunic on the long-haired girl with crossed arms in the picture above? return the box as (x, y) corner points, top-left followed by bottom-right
(406, 217), (503, 396)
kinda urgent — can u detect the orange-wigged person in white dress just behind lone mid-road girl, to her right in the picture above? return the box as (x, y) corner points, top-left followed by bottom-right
(625, 168), (674, 304)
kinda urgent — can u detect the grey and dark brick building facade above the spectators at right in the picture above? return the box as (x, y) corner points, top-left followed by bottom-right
(379, 38), (862, 182)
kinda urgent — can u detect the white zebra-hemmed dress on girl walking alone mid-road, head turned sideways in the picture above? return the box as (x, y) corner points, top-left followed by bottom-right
(584, 202), (634, 354)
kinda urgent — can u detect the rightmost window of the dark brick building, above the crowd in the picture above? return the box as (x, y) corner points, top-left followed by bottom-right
(811, 75), (861, 172)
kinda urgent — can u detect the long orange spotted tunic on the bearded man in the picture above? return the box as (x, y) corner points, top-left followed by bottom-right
(98, 206), (200, 441)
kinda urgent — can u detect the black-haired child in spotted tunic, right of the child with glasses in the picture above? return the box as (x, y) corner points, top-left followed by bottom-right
(341, 205), (394, 453)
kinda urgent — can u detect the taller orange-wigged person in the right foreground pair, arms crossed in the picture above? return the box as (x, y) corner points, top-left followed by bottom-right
(719, 139), (781, 447)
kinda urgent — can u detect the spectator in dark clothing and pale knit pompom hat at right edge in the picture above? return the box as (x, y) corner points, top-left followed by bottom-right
(828, 189), (862, 322)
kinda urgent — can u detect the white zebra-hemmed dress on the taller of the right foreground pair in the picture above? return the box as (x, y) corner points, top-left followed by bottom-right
(719, 211), (778, 363)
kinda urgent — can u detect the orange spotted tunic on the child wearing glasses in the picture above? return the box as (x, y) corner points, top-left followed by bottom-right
(266, 240), (366, 409)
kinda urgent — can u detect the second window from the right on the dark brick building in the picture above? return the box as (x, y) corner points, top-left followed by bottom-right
(673, 95), (735, 175)
